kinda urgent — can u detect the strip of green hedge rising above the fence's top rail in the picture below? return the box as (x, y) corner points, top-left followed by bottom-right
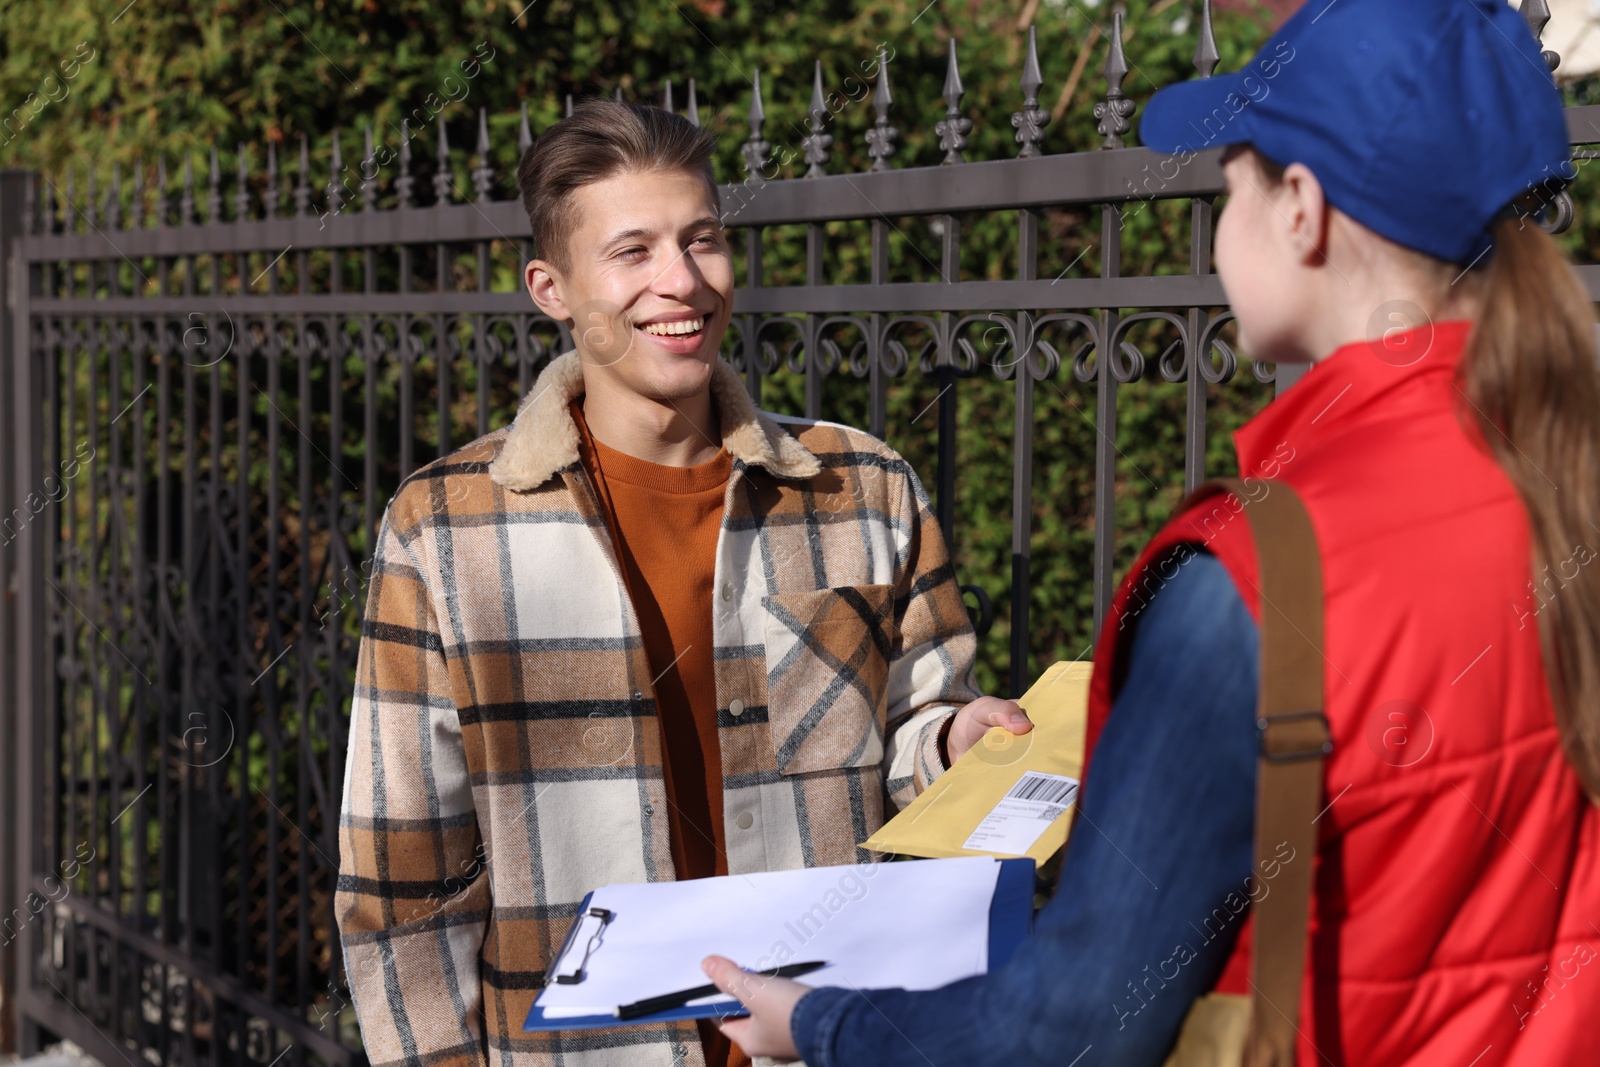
(0, 0), (1286, 204)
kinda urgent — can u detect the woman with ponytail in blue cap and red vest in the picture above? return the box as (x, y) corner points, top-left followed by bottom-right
(707, 0), (1600, 1067)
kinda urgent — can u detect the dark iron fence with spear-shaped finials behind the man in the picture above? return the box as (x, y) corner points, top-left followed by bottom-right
(0, 5), (1600, 1064)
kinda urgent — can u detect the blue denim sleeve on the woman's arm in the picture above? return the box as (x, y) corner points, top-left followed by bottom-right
(790, 552), (1258, 1067)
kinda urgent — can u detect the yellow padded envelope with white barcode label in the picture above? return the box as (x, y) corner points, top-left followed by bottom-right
(862, 661), (1091, 864)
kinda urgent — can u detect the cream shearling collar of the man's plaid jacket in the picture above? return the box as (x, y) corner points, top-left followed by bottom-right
(490, 349), (822, 491)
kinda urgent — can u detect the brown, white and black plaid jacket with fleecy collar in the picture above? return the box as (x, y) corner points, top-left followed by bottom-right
(336, 352), (978, 1067)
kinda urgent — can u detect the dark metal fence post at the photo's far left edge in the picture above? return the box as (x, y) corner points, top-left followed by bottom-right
(0, 170), (35, 1054)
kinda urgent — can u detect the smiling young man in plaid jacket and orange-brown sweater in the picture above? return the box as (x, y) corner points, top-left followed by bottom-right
(338, 101), (1029, 1067)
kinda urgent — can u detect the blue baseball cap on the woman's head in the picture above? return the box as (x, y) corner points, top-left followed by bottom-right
(1139, 0), (1574, 262)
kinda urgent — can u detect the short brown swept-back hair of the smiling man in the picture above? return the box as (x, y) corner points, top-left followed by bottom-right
(517, 98), (718, 270)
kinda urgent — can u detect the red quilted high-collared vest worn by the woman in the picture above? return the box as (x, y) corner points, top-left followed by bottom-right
(1088, 322), (1600, 1067)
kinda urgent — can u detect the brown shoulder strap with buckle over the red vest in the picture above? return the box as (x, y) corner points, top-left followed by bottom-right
(1184, 478), (1333, 1067)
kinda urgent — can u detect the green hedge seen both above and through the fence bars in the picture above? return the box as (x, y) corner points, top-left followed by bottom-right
(28, 0), (1600, 691)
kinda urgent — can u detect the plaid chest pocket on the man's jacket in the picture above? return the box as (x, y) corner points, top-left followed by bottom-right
(762, 585), (894, 774)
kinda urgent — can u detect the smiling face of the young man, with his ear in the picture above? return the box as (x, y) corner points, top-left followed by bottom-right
(528, 171), (733, 400)
